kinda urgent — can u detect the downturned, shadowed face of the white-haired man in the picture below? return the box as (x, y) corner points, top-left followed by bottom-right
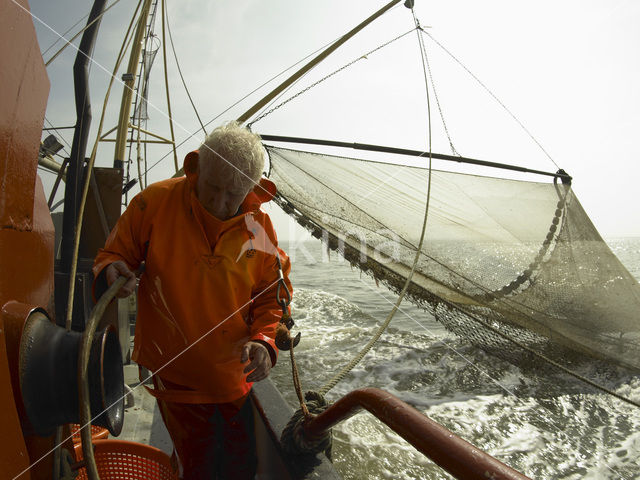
(197, 159), (254, 220)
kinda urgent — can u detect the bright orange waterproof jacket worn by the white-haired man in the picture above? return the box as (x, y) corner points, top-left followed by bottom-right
(93, 154), (291, 403)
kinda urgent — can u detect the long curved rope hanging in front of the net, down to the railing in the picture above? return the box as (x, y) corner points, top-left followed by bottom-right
(319, 8), (432, 395)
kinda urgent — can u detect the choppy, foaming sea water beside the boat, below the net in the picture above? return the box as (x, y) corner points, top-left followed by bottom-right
(272, 238), (640, 480)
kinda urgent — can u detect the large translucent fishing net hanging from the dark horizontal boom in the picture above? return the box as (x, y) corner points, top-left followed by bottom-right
(267, 146), (640, 369)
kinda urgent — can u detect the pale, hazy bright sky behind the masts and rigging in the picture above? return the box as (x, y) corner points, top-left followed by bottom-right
(25, 0), (640, 239)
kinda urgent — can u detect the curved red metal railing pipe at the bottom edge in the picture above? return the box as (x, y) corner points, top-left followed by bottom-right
(303, 388), (528, 480)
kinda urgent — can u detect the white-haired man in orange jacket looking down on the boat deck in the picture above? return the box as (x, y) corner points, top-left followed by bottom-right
(93, 122), (291, 480)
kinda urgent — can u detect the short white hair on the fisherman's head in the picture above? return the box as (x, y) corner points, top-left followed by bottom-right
(198, 121), (264, 185)
